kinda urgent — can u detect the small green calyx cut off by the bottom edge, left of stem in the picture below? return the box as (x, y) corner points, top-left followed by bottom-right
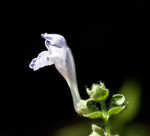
(90, 124), (104, 136)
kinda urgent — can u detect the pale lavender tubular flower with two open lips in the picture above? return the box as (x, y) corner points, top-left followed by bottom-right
(29, 33), (80, 111)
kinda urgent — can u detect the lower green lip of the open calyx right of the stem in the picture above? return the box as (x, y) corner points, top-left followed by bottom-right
(108, 106), (126, 117)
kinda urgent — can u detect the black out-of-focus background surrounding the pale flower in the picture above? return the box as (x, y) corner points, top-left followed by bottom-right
(0, 0), (150, 136)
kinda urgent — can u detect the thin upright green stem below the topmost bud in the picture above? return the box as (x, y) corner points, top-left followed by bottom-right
(100, 101), (110, 136)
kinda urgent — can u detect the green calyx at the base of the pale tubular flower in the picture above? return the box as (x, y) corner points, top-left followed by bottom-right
(79, 99), (102, 119)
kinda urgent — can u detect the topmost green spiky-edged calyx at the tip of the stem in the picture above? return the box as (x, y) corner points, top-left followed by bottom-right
(86, 83), (109, 102)
